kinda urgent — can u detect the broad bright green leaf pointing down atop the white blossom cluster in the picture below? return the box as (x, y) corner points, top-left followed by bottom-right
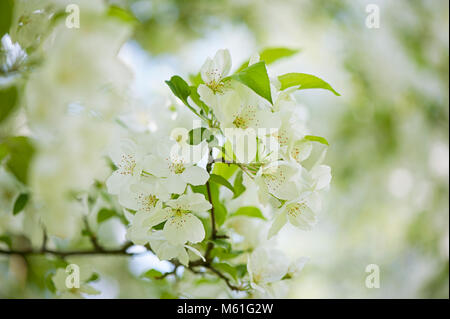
(224, 62), (272, 104)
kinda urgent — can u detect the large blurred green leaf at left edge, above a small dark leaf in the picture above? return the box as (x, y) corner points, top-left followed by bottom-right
(0, 136), (35, 184)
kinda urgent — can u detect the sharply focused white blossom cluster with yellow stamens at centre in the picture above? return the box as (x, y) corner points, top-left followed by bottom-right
(106, 50), (332, 293)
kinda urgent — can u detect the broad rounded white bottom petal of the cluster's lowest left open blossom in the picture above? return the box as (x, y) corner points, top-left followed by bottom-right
(163, 213), (205, 245)
